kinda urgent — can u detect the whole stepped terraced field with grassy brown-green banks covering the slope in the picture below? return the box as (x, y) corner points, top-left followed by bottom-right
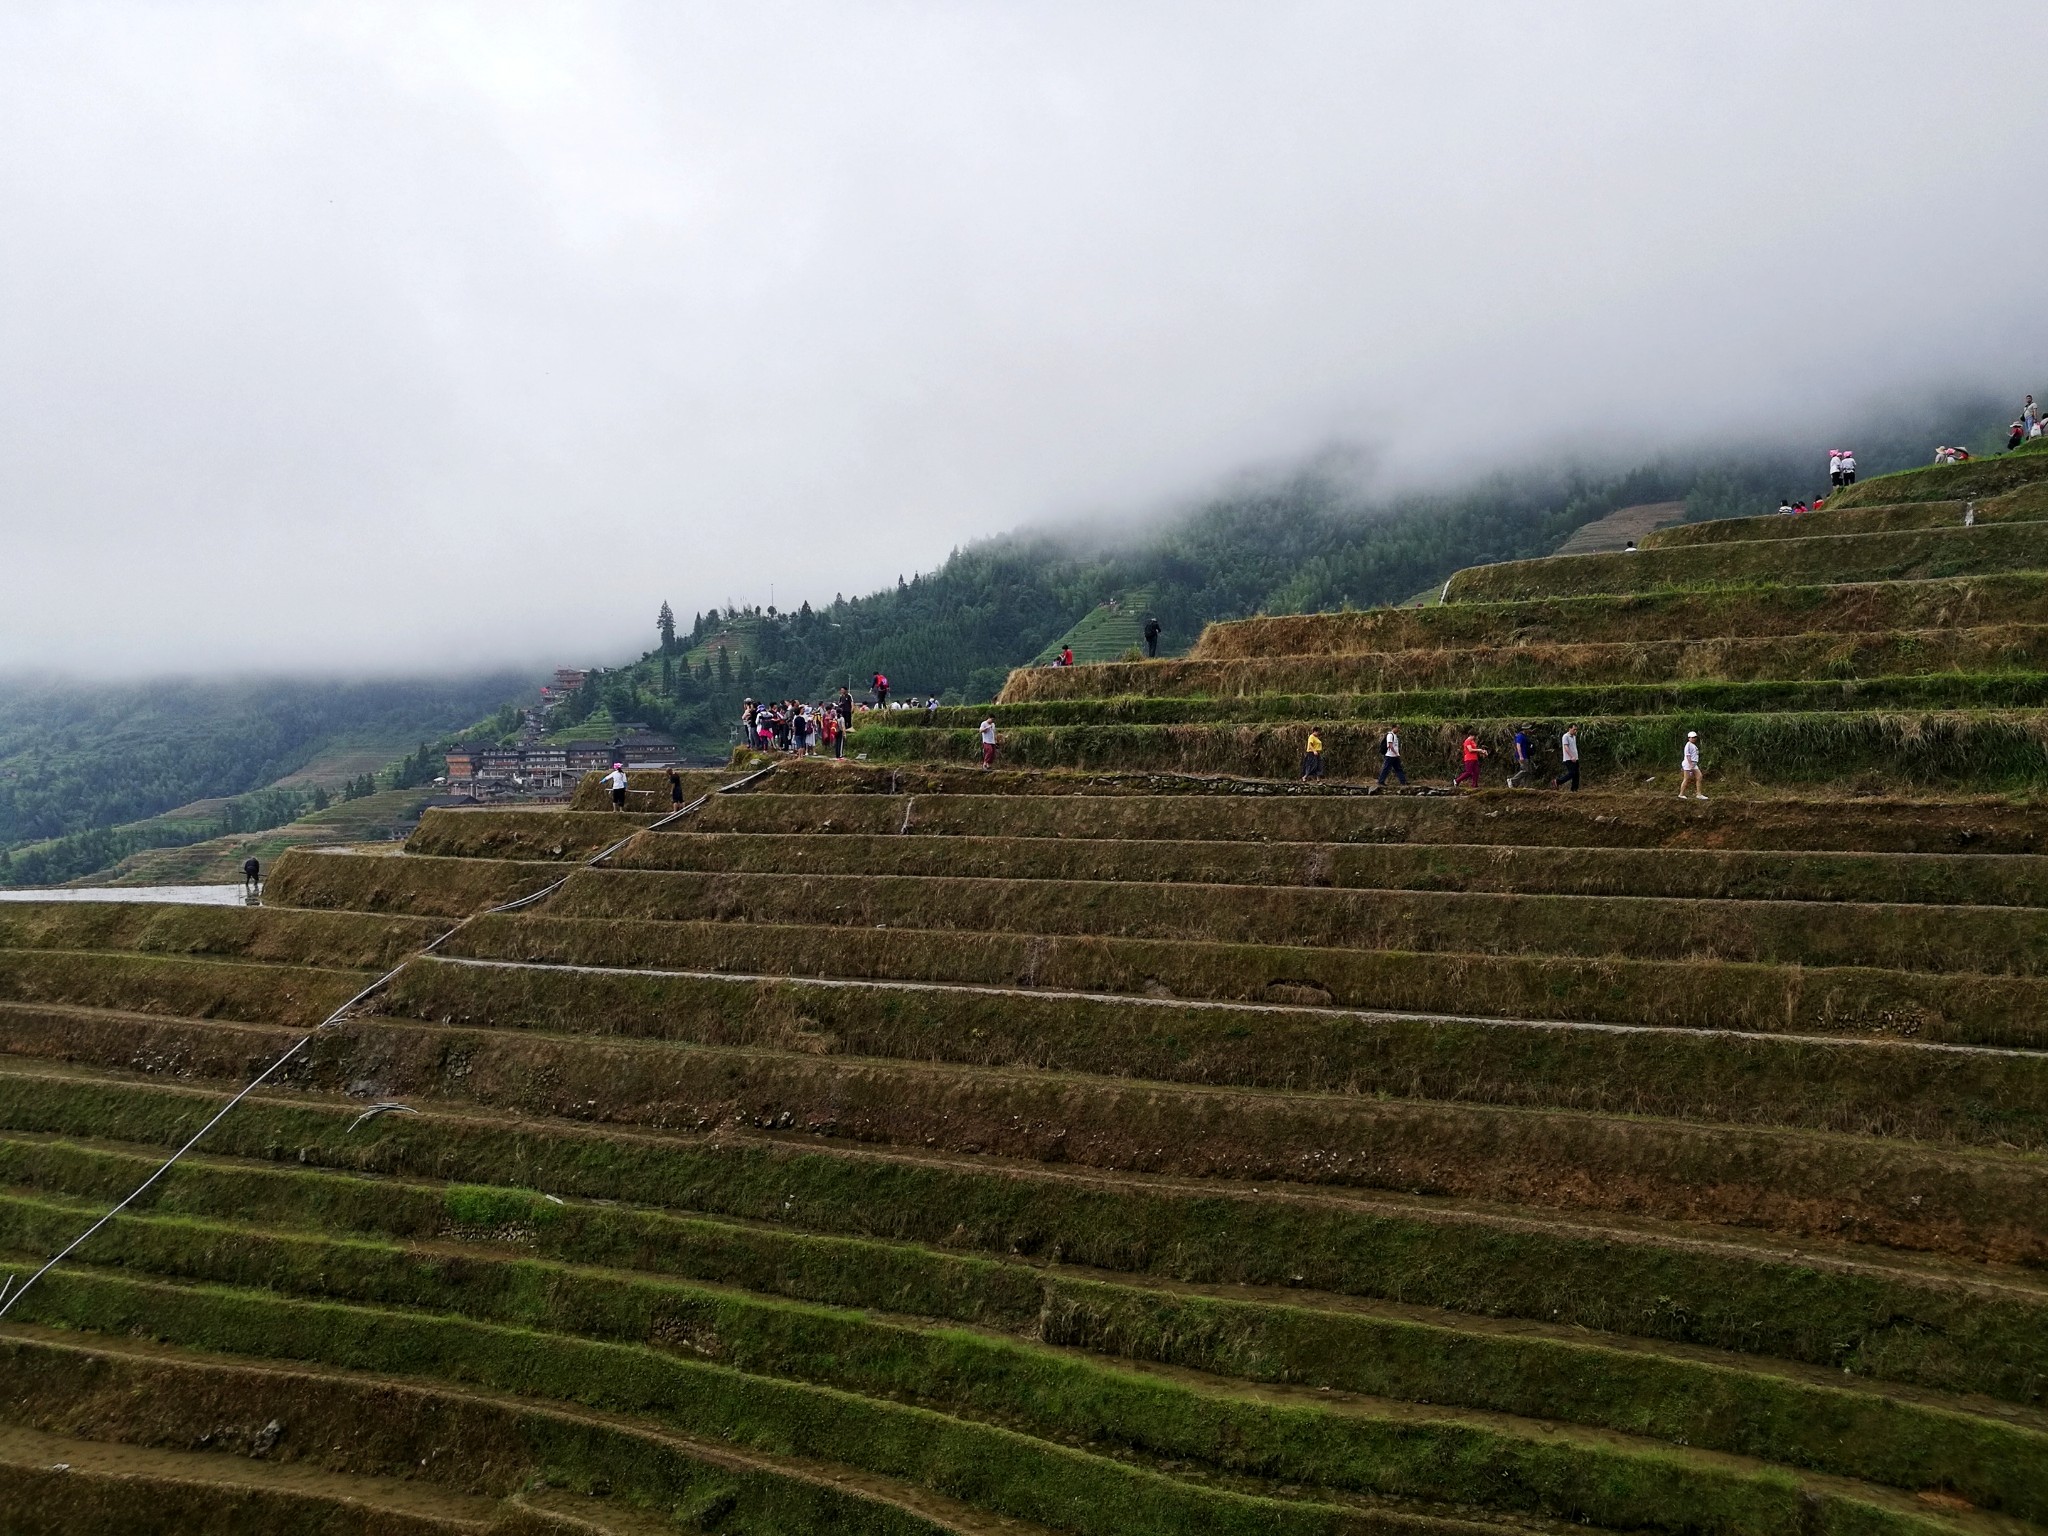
(0, 459), (2048, 1536)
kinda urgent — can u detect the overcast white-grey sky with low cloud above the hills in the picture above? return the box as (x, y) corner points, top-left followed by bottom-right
(0, 0), (2048, 672)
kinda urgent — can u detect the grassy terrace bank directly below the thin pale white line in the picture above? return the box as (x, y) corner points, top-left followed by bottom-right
(379, 961), (2048, 1149)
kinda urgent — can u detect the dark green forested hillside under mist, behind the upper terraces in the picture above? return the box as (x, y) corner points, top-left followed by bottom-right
(565, 401), (1995, 758)
